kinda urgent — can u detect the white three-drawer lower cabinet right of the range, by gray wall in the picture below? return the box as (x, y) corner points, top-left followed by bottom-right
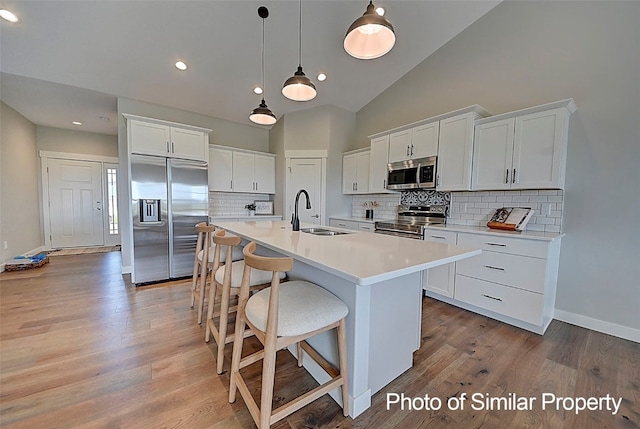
(424, 230), (560, 334)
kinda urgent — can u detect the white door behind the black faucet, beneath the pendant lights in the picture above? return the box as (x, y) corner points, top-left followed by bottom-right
(285, 158), (324, 225)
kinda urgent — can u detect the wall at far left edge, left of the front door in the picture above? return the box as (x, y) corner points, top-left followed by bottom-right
(0, 102), (43, 262)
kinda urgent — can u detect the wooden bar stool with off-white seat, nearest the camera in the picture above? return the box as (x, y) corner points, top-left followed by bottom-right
(229, 242), (349, 429)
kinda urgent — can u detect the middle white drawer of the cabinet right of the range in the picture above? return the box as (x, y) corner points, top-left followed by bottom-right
(456, 250), (547, 293)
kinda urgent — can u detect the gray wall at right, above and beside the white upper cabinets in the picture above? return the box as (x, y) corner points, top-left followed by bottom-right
(356, 1), (640, 329)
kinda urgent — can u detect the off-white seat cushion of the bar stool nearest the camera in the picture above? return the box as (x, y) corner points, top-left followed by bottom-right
(245, 280), (349, 337)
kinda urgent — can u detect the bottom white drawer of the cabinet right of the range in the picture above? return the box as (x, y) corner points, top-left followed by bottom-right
(454, 274), (543, 325)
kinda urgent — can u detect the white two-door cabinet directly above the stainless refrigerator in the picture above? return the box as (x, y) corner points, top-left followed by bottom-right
(125, 115), (211, 161)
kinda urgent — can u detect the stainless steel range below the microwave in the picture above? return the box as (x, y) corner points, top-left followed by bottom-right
(375, 205), (447, 240)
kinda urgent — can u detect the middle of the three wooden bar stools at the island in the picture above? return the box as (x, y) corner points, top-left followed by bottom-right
(204, 230), (286, 374)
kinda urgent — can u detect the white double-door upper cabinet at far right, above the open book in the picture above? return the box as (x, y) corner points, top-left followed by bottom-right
(472, 99), (576, 190)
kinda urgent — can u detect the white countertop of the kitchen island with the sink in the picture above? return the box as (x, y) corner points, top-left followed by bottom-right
(213, 221), (481, 286)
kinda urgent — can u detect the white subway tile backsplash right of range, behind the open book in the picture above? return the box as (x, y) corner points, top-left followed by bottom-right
(447, 190), (564, 232)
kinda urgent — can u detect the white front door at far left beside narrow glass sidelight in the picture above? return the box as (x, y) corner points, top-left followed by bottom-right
(47, 159), (104, 248)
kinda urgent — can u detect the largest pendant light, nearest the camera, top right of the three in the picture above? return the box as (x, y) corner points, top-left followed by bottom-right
(344, 1), (396, 60)
